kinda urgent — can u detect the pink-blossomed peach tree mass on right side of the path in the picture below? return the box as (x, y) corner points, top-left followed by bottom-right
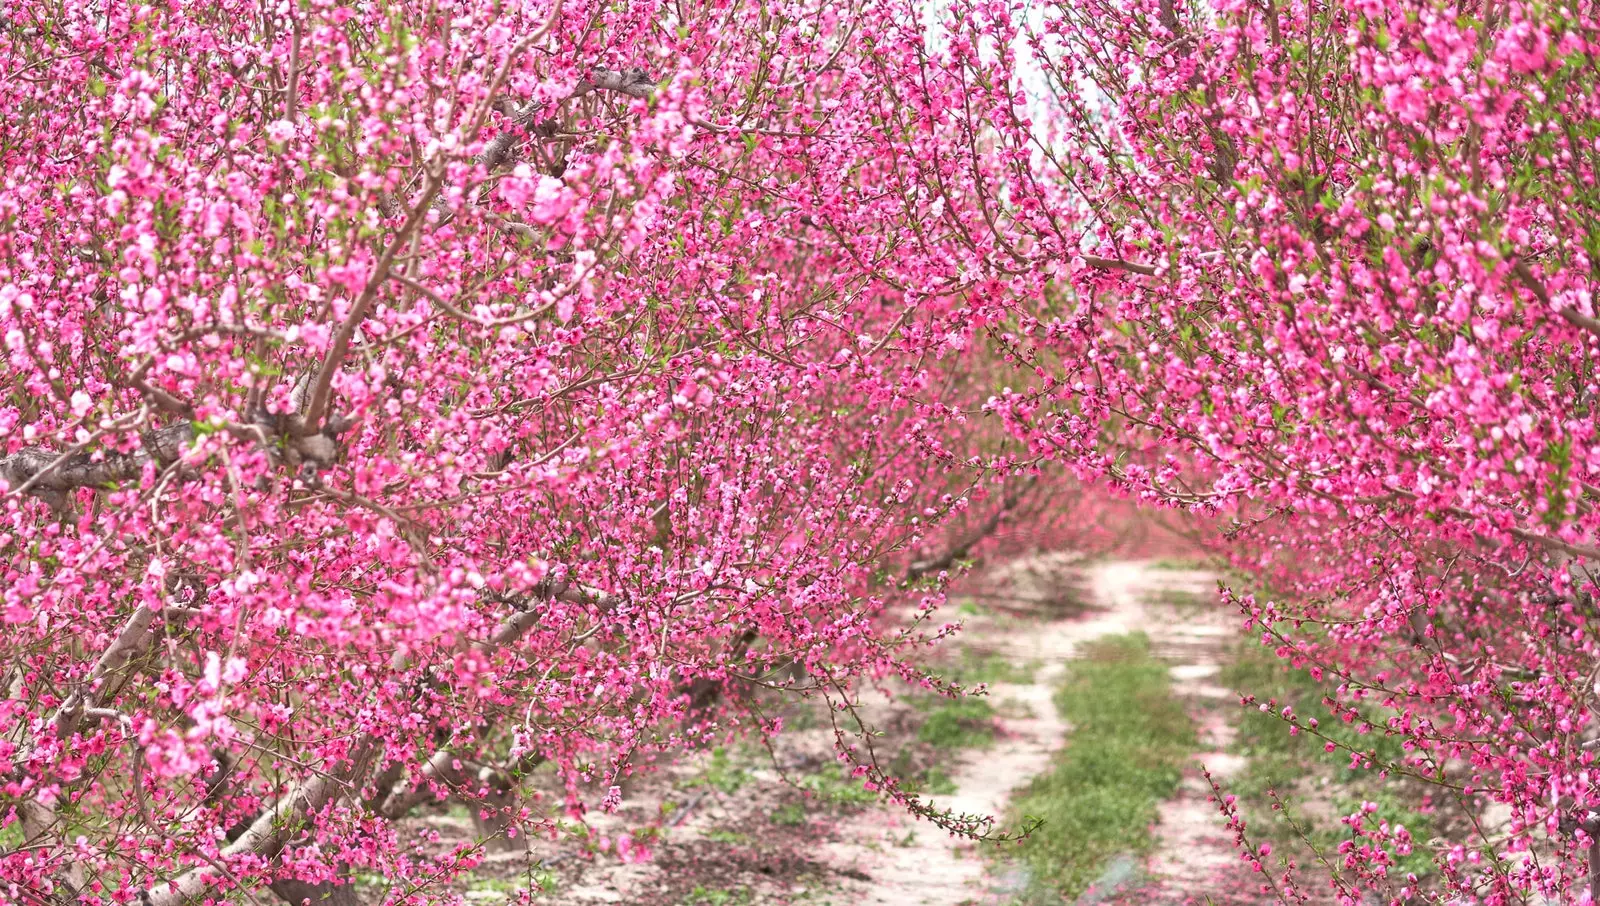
(915, 0), (1600, 903)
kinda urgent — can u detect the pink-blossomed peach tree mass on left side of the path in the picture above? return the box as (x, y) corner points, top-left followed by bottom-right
(0, 0), (1061, 906)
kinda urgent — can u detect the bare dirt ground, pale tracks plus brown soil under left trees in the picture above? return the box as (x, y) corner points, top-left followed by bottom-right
(396, 554), (1240, 906)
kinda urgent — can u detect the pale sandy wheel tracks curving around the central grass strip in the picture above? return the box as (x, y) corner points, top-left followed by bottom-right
(822, 560), (1242, 906)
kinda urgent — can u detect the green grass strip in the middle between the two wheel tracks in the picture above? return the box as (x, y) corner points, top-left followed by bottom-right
(1016, 632), (1197, 900)
